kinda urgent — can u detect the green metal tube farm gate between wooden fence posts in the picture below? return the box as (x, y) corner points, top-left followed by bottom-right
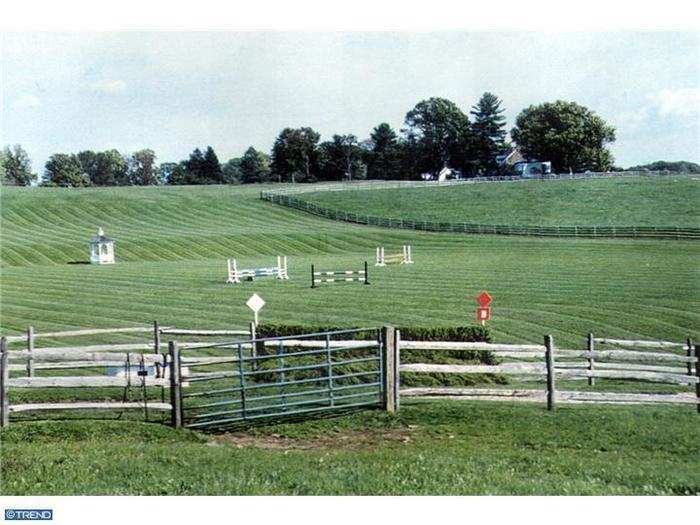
(171, 328), (386, 430)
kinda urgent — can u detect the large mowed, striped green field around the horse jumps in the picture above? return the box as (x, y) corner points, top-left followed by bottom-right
(0, 181), (700, 345)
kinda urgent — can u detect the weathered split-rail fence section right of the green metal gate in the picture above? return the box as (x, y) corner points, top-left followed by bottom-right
(399, 334), (700, 413)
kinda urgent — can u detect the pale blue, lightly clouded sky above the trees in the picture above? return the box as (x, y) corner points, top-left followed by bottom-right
(0, 31), (700, 174)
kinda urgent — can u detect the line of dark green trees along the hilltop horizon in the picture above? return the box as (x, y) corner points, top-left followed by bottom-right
(0, 93), (615, 187)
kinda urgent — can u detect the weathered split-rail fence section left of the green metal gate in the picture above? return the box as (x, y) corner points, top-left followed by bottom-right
(0, 322), (255, 426)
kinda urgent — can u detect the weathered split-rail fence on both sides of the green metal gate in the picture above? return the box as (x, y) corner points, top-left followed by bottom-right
(0, 323), (700, 426)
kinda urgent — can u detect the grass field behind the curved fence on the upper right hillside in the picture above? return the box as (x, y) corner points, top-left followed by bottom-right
(303, 176), (700, 227)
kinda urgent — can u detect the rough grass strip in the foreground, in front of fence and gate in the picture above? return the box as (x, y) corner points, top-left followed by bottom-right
(0, 401), (700, 495)
